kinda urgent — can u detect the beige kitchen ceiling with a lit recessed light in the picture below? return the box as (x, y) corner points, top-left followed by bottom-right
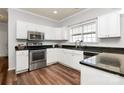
(21, 8), (86, 21)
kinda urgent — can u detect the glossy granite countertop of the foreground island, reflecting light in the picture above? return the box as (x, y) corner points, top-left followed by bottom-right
(80, 53), (124, 76)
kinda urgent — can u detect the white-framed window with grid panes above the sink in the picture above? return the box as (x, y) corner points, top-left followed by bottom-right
(69, 20), (97, 42)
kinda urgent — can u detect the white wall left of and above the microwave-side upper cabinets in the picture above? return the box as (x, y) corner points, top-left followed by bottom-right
(8, 8), (57, 70)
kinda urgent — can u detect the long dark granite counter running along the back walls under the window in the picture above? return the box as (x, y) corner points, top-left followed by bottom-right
(15, 45), (124, 54)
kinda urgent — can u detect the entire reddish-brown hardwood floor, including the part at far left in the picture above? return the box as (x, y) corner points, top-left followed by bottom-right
(0, 58), (80, 85)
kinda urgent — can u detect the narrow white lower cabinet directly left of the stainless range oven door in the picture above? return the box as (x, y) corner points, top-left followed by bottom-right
(16, 50), (29, 73)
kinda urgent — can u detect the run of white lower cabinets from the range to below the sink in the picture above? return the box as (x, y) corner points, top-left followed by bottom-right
(47, 48), (83, 70)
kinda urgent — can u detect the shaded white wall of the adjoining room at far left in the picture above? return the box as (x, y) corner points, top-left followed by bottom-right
(0, 23), (8, 57)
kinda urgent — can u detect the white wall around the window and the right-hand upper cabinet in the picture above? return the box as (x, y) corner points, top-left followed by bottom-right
(59, 8), (124, 48)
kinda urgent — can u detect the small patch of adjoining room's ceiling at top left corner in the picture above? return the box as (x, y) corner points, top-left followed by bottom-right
(0, 8), (8, 23)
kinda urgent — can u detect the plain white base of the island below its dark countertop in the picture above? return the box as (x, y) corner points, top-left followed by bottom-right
(81, 65), (124, 85)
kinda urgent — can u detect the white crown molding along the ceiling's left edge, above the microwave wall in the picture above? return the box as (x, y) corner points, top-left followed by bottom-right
(13, 8), (59, 23)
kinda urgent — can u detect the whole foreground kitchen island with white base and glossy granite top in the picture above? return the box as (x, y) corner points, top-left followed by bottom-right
(80, 53), (124, 85)
